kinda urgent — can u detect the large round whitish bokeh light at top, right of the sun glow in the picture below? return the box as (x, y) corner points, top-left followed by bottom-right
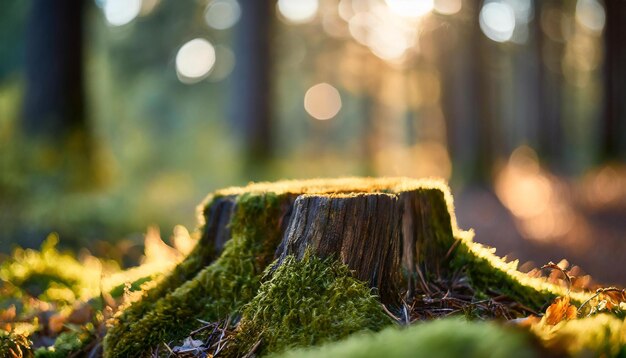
(479, 1), (515, 42)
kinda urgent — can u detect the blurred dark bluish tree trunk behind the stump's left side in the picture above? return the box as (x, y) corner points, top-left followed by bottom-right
(231, 0), (274, 179)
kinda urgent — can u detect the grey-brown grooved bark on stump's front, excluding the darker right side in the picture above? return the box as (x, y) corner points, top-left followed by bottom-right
(277, 194), (402, 301)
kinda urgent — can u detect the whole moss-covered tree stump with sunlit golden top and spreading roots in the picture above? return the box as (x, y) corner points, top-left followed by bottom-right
(104, 178), (576, 357)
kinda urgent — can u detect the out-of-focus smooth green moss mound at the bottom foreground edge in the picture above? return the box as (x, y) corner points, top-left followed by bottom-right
(273, 319), (540, 358)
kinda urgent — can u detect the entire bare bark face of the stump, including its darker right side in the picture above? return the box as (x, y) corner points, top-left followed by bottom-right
(276, 190), (454, 303)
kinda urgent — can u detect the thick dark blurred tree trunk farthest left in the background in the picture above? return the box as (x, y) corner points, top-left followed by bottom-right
(22, 0), (86, 139)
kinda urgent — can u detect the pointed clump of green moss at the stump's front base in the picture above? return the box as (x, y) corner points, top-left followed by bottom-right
(227, 254), (392, 356)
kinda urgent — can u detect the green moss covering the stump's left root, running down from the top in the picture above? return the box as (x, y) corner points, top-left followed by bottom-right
(105, 193), (281, 357)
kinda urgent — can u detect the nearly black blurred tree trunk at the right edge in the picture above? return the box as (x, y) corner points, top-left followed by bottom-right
(603, 0), (626, 159)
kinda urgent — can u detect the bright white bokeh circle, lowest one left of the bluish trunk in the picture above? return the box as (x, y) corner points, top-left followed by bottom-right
(176, 38), (215, 84)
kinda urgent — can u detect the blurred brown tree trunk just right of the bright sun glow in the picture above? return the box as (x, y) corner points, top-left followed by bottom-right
(438, 0), (496, 184)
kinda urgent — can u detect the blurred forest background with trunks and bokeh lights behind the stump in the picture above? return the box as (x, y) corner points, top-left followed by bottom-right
(0, 0), (626, 285)
